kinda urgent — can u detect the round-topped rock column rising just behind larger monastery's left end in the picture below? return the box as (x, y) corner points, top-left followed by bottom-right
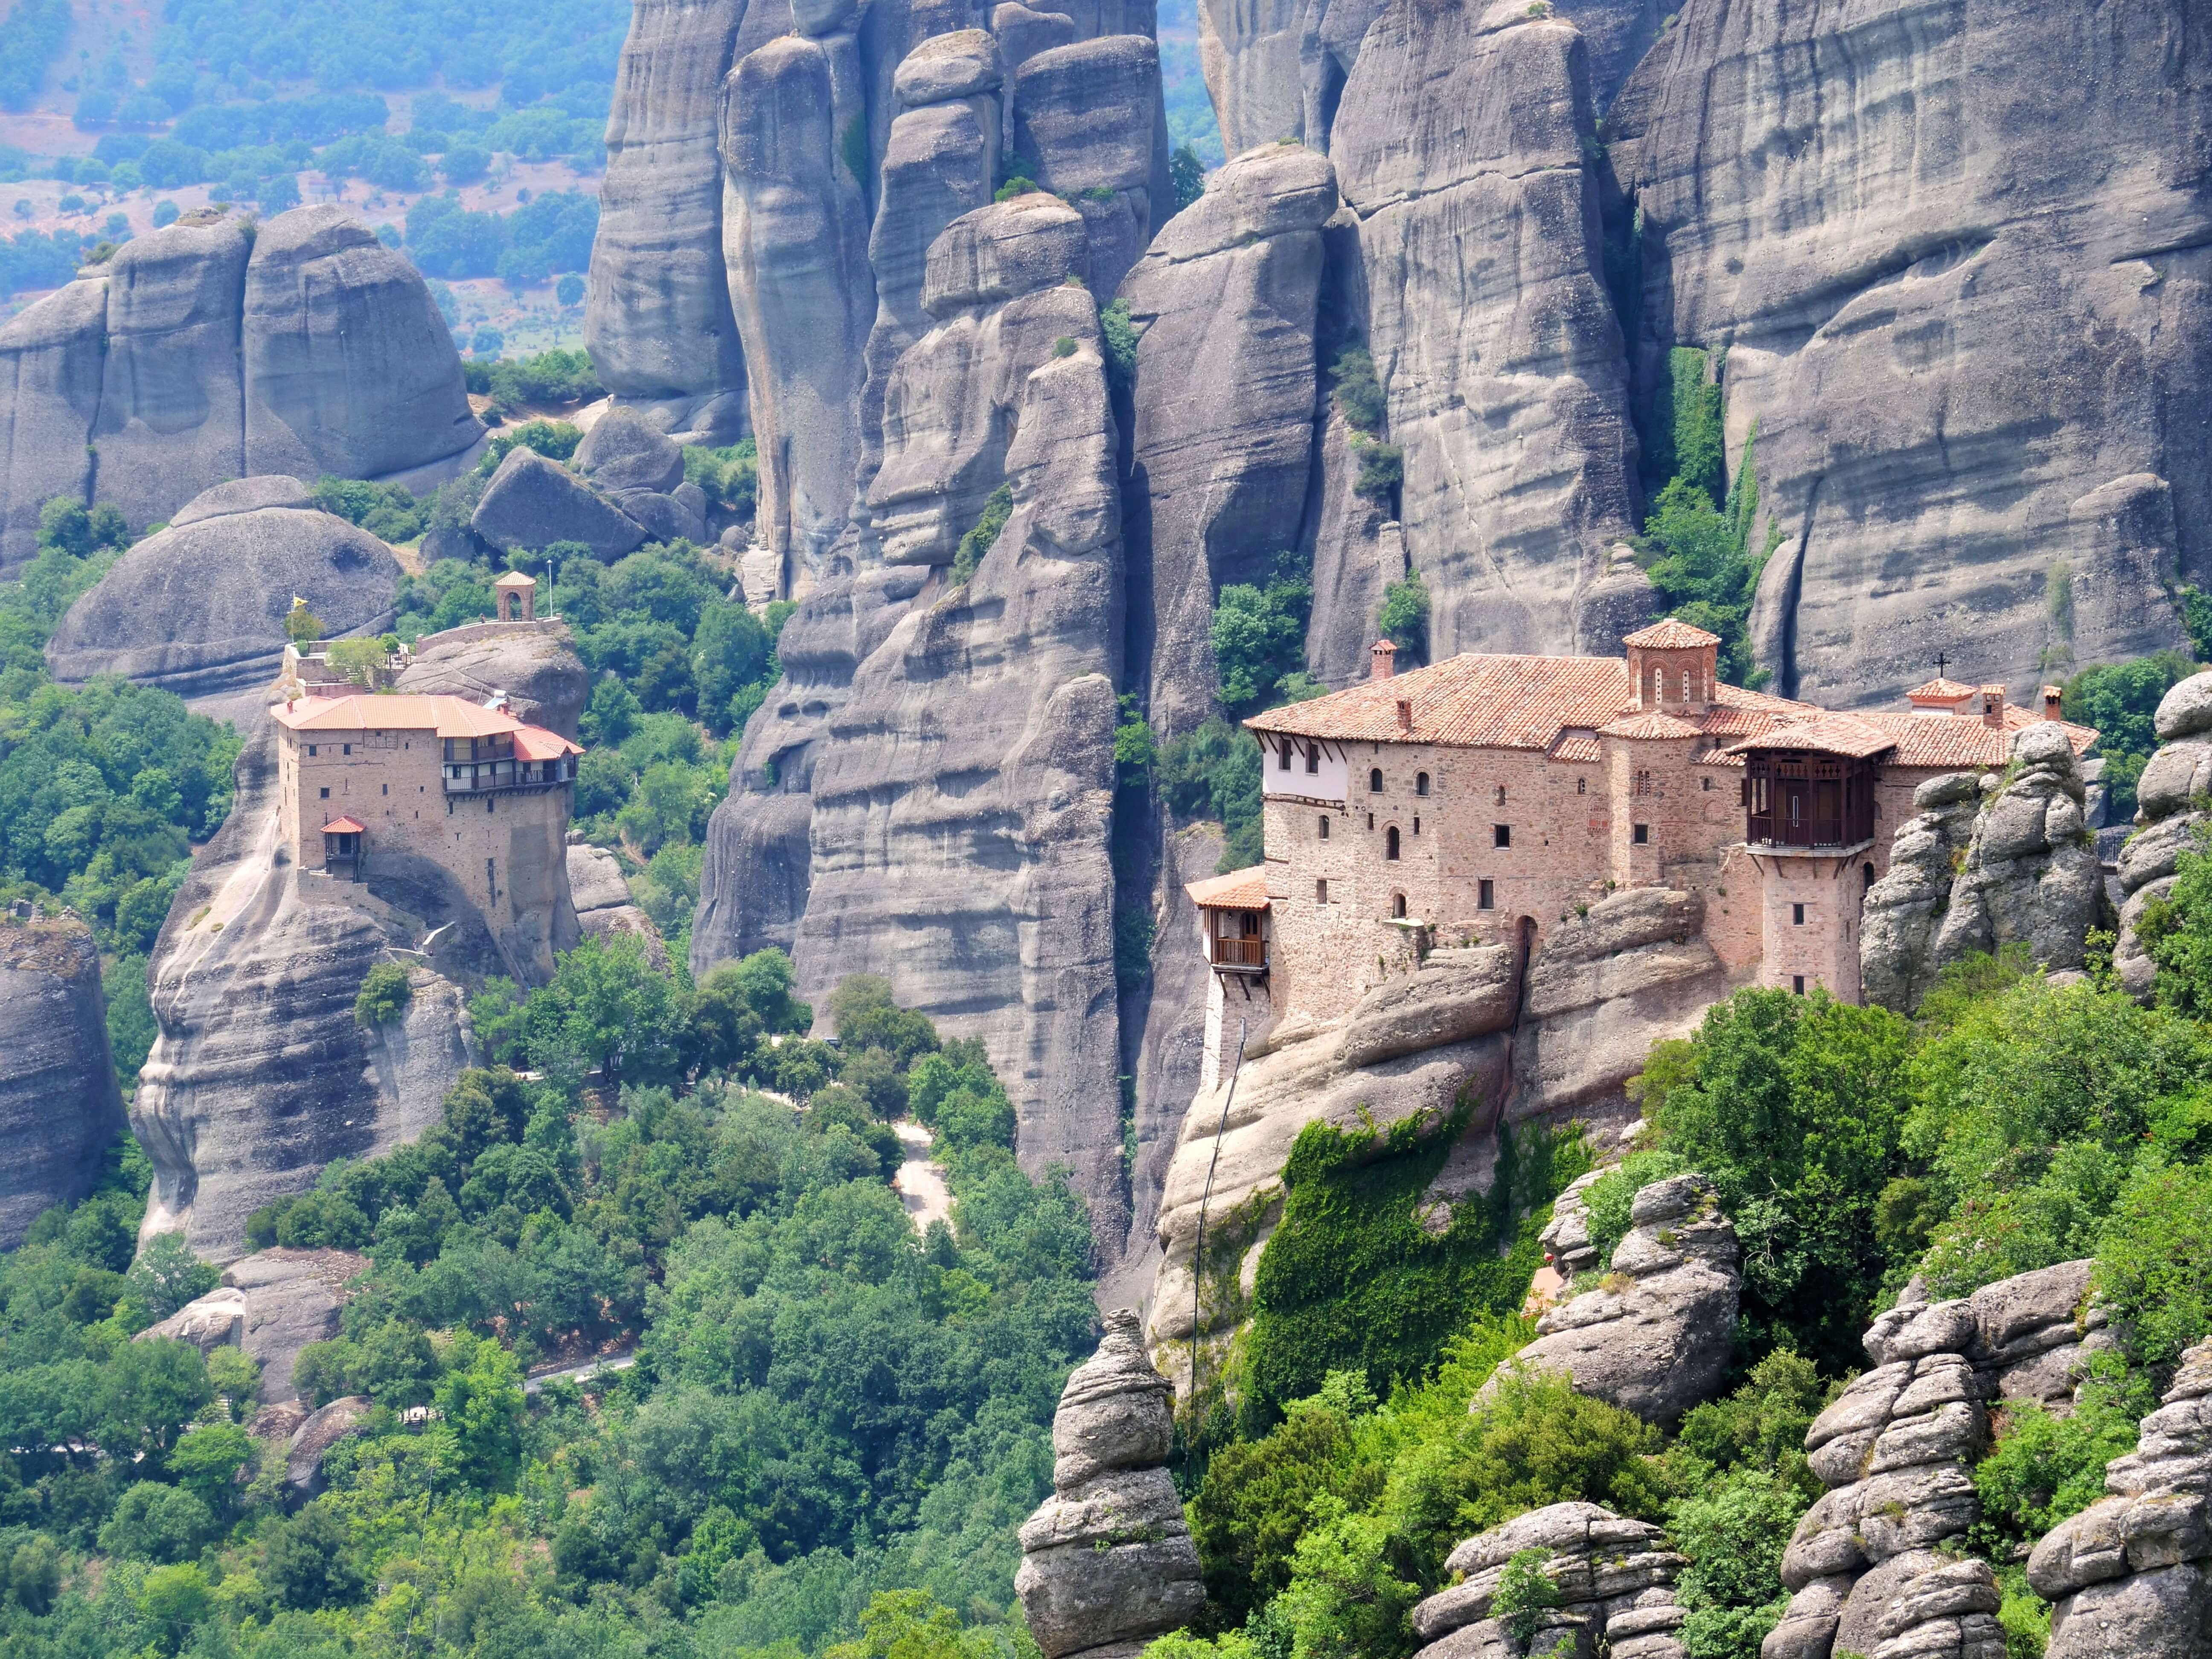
(1119, 144), (1336, 736)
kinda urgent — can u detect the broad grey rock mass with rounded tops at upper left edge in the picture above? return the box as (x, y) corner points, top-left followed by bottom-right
(0, 206), (484, 573)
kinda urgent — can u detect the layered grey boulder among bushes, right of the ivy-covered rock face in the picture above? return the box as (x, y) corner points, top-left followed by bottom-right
(1476, 1175), (1743, 1424)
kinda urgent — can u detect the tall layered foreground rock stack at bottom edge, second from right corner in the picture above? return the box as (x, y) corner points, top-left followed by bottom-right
(1761, 1261), (2104, 1659)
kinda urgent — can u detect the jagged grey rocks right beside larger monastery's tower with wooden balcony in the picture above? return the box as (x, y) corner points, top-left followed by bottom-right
(1858, 721), (2104, 1011)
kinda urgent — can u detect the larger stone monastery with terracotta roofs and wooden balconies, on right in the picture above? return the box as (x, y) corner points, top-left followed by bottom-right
(1188, 622), (2097, 1053)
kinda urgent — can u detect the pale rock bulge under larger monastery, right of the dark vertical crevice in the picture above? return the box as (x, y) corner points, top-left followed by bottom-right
(1506, 887), (1732, 1121)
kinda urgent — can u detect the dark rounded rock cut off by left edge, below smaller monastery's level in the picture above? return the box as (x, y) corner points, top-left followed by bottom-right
(0, 918), (124, 1250)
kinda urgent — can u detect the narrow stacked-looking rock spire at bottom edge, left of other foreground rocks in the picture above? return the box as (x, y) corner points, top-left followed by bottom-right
(1013, 1307), (1205, 1659)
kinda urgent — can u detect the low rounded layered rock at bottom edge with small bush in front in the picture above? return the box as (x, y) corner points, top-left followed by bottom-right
(1414, 1502), (1690, 1659)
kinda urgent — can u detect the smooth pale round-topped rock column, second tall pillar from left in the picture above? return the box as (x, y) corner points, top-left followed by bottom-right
(721, 0), (876, 591)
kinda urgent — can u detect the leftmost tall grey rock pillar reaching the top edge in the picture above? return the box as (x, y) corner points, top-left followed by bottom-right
(584, 0), (765, 445)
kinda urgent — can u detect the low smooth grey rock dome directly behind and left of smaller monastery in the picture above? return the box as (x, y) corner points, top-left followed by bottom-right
(47, 476), (400, 697)
